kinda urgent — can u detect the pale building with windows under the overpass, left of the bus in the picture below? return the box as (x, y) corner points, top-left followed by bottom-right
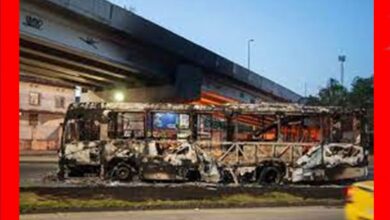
(19, 79), (74, 151)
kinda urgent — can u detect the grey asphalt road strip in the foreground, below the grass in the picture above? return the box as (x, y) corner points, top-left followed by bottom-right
(20, 207), (344, 220)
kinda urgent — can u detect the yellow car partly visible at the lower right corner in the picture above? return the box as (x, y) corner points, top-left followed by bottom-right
(345, 181), (374, 220)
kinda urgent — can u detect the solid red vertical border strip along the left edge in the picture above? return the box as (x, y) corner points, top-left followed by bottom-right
(0, 0), (19, 220)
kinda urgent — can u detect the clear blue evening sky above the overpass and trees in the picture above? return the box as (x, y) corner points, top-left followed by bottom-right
(110, 0), (374, 95)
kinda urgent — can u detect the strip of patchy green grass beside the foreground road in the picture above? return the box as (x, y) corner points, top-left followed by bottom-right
(20, 192), (338, 213)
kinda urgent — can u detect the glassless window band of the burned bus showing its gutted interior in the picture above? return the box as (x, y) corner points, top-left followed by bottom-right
(64, 104), (364, 155)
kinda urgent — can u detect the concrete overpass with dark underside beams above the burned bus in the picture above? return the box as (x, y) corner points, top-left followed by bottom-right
(20, 0), (301, 103)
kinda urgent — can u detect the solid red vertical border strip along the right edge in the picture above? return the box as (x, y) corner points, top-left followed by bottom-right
(374, 0), (390, 219)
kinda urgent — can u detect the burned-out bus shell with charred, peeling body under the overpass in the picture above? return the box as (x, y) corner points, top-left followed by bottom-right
(59, 103), (367, 184)
